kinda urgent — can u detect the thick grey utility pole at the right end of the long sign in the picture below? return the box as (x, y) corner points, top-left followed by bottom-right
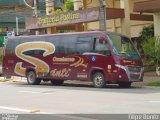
(99, 0), (107, 31)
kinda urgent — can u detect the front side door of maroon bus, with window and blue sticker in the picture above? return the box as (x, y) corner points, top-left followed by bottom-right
(91, 36), (114, 80)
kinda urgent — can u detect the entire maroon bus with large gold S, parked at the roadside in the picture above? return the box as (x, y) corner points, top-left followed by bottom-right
(3, 31), (144, 88)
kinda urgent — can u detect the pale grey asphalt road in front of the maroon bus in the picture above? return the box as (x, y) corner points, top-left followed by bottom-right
(0, 78), (160, 120)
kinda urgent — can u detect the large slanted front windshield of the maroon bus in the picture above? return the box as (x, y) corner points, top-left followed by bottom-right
(108, 34), (140, 59)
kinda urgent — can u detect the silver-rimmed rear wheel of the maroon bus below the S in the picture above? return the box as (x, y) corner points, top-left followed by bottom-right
(27, 71), (41, 85)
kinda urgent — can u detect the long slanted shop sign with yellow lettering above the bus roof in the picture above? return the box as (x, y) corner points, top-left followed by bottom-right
(25, 8), (99, 29)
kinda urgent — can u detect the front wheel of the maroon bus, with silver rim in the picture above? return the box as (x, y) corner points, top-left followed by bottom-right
(92, 72), (106, 88)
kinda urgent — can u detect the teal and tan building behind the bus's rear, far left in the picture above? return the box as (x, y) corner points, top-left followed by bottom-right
(0, 0), (32, 35)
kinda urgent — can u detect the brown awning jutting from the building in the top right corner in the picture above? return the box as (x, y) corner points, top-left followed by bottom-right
(133, 0), (160, 13)
